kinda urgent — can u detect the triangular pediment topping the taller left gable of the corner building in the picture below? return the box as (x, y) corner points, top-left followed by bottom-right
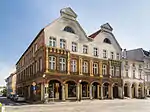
(60, 7), (77, 18)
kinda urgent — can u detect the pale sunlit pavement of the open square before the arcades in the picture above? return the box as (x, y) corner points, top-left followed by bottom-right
(5, 99), (150, 112)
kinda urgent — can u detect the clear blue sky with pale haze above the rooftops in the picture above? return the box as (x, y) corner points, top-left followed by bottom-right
(0, 0), (150, 85)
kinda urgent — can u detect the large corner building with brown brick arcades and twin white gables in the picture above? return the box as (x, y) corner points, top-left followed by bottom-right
(16, 8), (123, 100)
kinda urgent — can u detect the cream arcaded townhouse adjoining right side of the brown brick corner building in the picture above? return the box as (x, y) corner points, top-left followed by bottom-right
(122, 49), (146, 98)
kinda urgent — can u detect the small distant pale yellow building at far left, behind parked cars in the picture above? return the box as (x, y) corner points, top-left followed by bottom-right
(5, 73), (16, 95)
